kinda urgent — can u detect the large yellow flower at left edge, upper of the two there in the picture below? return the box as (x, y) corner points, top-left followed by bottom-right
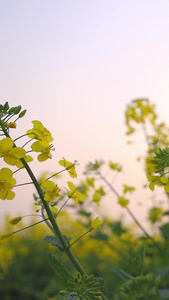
(0, 137), (26, 166)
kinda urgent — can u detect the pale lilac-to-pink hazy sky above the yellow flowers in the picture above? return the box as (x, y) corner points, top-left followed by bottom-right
(0, 0), (169, 229)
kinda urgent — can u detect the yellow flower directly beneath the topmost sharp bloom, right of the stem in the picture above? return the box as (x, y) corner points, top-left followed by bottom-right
(31, 141), (53, 162)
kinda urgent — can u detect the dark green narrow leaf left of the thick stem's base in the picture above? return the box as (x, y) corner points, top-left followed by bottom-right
(49, 254), (74, 283)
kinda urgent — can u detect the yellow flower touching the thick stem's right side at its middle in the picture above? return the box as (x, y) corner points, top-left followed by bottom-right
(41, 180), (60, 202)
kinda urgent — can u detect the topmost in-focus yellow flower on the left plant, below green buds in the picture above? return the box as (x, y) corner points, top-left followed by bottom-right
(26, 121), (53, 143)
